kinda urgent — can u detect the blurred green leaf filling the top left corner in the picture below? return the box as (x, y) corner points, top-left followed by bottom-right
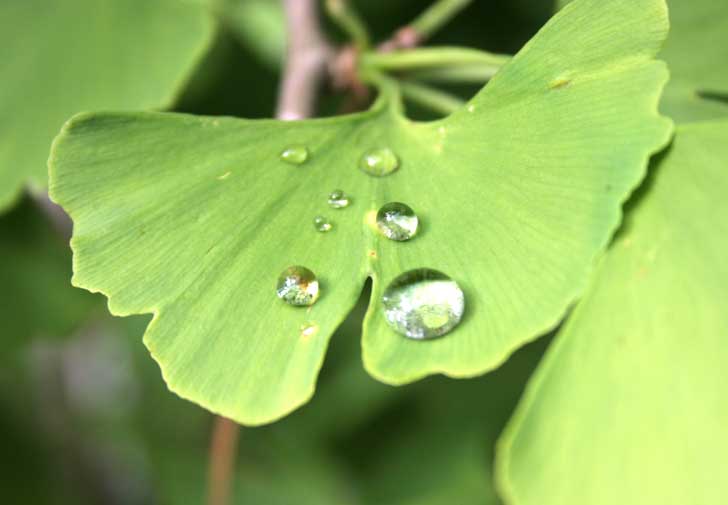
(0, 0), (212, 209)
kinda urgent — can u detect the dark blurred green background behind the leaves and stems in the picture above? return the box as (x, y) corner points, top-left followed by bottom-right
(0, 0), (553, 505)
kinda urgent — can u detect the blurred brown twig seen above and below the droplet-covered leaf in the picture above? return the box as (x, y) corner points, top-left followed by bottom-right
(208, 0), (333, 505)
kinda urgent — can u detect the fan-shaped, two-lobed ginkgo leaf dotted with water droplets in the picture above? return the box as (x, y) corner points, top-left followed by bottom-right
(50, 0), (671, 424)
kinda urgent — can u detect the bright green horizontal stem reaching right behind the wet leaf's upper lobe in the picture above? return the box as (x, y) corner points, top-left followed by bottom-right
(361, 47), (510, 72)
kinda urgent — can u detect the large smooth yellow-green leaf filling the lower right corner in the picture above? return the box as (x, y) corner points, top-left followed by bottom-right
(498, 120), (728, 505)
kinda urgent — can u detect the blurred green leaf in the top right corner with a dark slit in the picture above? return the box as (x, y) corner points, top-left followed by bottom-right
(557, 0), (728, 122)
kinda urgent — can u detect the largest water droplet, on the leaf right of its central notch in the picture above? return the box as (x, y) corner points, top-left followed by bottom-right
(382, 268), (465, 340)
